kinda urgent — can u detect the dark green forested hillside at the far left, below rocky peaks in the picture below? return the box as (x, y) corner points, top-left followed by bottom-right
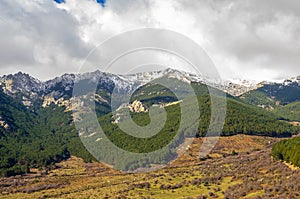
(0, 92), (93, 176)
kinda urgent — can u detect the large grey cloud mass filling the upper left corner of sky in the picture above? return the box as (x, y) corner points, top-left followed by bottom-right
(0, 0), (90, 79)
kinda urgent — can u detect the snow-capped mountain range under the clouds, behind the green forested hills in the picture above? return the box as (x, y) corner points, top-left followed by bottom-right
(0, 68), (300, 107)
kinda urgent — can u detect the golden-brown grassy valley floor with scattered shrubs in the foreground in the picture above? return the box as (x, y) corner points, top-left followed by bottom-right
(0, 135), (300, 199)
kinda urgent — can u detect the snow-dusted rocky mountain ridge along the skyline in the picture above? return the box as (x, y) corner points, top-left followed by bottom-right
(0, 68), (300, 109)
